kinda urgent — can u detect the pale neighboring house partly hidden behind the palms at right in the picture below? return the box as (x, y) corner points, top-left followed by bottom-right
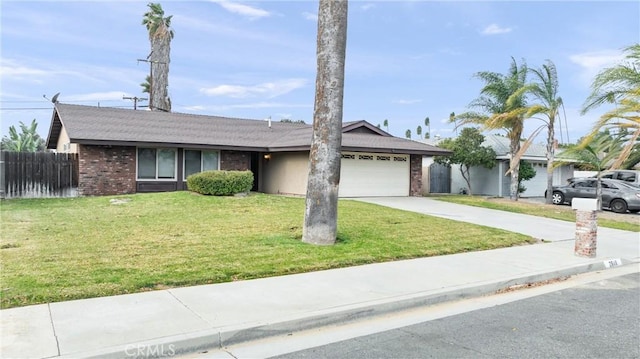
(423, 135), (574, 197)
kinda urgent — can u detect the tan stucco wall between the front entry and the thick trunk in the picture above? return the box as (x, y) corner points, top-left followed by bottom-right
(262, 152), (309, 196)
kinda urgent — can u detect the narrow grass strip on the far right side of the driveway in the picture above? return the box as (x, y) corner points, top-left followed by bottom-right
(433, 195), (640, 232)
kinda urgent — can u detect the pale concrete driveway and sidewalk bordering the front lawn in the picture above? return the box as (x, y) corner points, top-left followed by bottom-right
(0, 198), (640, 358)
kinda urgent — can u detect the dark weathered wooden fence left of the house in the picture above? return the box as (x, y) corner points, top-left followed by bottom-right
(0, 151), (78, 198)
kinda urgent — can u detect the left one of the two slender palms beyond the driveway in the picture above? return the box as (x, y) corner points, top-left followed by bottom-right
(450, 57), (528, 201)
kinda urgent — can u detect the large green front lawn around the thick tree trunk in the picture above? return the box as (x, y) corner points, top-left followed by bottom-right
(0, 192), (533, 308)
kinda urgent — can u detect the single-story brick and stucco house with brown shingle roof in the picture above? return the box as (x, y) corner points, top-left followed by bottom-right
(47, 103), (447, 197)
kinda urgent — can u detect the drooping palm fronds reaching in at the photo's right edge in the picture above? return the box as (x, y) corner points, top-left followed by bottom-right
(582, 44), (640, 169)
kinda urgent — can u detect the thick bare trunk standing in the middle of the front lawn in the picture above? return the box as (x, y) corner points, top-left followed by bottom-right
(302, 0), (347, 245)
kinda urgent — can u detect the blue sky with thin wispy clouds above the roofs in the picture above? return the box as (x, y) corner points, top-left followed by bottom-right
(0, 0), (640, 142)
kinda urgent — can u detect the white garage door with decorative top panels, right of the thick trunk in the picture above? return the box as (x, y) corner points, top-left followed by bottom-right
(339, 152), (410, 197)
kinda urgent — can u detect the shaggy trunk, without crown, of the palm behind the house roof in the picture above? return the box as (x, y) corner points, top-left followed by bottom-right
(149, 34), (171, 112)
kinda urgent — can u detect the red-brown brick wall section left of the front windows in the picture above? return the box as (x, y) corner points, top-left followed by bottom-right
(78, 145), (136, 196)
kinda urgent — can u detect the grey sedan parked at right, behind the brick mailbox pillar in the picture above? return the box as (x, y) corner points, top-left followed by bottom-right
(545, 177), (640, 213)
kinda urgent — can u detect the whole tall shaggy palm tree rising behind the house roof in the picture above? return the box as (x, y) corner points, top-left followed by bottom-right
(142, 3), (174, 112)
